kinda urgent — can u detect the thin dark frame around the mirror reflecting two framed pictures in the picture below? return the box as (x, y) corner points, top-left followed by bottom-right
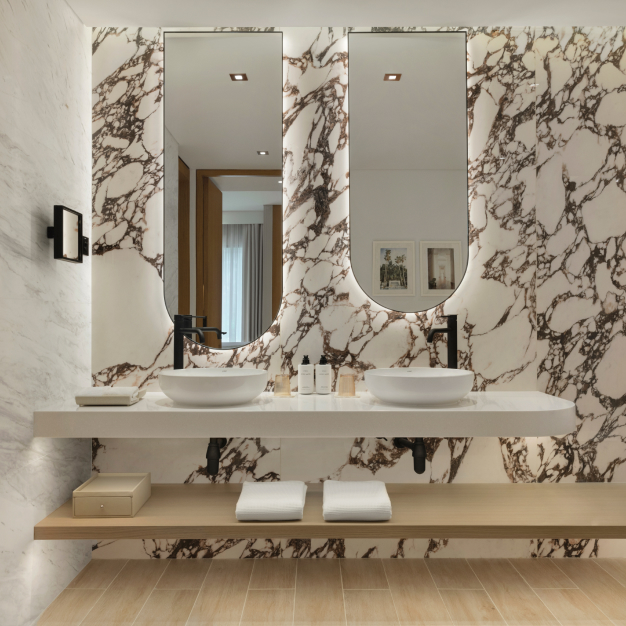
(347, 30), (470, 315)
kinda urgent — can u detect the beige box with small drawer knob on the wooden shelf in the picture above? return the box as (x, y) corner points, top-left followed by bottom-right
(72, 472), (152, 517)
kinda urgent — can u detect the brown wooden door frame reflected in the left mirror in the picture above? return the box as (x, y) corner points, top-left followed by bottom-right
(196, 170), (283, 349)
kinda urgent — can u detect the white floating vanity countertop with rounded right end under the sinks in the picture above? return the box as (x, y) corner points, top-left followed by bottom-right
(34, 391), (576, 439)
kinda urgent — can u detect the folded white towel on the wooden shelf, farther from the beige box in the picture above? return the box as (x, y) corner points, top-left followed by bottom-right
(323, 480), (391, 522)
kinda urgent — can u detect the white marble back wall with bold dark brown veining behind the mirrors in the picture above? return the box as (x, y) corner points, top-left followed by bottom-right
(93, 27), (626, 557)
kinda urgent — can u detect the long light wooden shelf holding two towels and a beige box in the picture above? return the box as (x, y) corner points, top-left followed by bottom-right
(35, 483), (626, 539)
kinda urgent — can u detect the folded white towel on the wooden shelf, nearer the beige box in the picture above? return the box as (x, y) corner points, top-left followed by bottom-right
(235, 480), (306, 522)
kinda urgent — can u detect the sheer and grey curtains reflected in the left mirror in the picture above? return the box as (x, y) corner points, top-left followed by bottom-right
(222, 224), (263, 344)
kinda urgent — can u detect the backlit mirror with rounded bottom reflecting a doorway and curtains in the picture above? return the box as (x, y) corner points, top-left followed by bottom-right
(163, 32), (283, 348)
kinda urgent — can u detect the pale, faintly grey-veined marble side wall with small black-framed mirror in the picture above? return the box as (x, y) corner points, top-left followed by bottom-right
(0, 0), (91, 626)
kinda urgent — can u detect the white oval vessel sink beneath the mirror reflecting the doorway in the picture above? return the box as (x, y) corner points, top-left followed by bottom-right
(159, 367), (267, 407)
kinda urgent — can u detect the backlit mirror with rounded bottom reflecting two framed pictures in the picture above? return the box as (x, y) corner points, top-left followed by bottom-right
(348, 32), (468, 312)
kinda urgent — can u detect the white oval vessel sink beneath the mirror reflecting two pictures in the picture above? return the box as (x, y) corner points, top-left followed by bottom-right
(365, 367), (474, 406)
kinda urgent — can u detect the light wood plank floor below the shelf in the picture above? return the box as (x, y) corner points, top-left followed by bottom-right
(38, 559), (626, 626)
